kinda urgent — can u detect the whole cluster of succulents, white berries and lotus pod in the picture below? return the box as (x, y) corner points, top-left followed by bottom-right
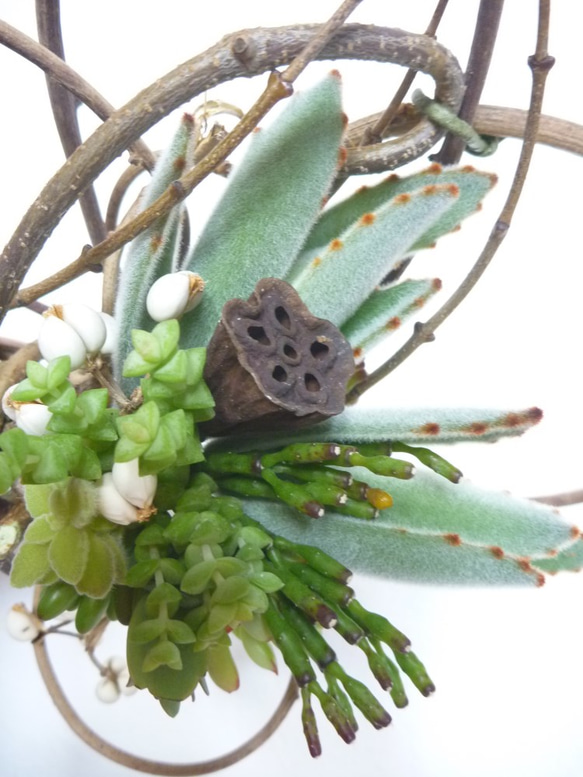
(0, 3), (583, 772)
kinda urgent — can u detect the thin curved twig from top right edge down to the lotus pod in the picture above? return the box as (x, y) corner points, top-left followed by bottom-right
(347, 0), (554, 402)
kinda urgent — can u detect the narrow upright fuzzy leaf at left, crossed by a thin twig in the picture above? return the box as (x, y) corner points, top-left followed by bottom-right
(113, 114), (195, 390)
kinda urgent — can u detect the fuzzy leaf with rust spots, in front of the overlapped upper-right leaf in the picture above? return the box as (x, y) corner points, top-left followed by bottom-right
(288, 186), (458, 326)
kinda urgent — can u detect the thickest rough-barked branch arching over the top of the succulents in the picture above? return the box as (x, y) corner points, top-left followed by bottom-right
(0, 25), (462, 320)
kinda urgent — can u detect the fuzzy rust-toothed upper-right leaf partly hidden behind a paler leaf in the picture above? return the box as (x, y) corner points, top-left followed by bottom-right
(304, 165), (496, 254)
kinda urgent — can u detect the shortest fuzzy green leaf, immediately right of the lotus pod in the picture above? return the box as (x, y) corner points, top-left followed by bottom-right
(342, 278), (441, 360)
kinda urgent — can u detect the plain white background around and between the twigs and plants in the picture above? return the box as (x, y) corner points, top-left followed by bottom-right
(0, 0), (583, 777)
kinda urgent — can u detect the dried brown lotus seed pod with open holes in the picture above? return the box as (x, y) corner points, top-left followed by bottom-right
(204, 278), (354, 435)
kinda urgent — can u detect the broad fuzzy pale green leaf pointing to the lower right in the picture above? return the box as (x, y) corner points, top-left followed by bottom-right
(246, 471), (578, 585)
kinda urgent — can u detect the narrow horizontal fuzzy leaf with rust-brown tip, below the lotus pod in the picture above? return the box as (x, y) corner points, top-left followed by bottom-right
(206, 406), (542, 453)
